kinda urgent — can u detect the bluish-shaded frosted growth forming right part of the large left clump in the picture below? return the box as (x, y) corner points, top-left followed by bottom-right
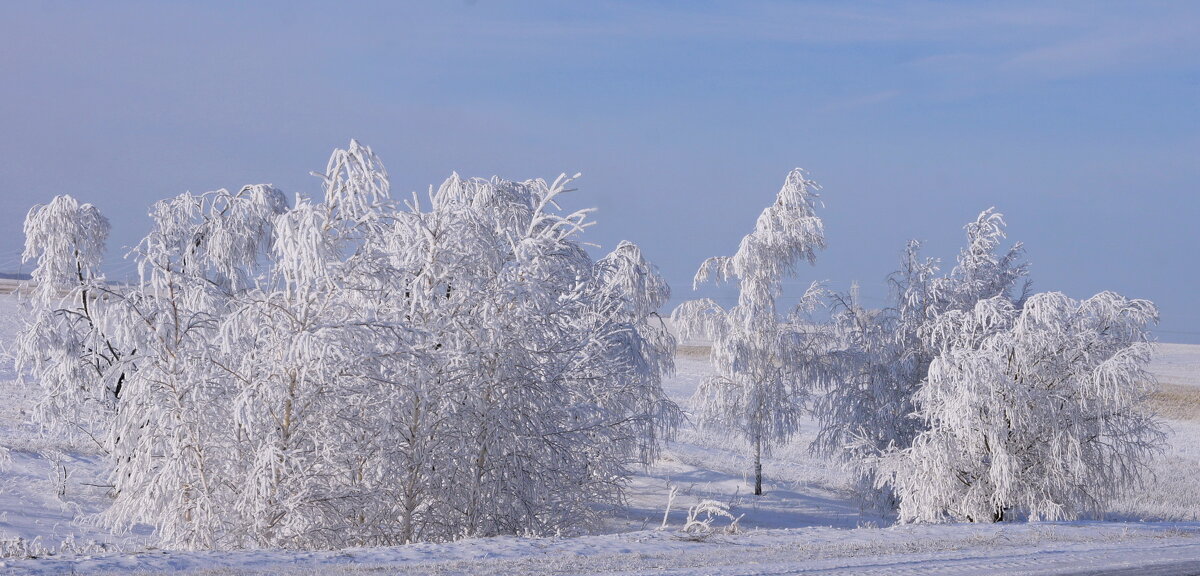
(388, 171), (678, 538)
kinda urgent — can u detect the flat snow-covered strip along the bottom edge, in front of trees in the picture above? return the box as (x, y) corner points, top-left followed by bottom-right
(0, 523), (1200, 576)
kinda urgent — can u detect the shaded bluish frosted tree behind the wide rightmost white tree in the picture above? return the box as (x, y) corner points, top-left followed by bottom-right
(814, 209), (1028, 510)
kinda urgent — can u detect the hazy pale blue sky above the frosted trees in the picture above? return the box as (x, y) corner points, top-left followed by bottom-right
(0, 0), (1200, 342)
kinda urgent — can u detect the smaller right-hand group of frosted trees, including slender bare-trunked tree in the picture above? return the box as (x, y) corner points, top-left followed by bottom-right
(673, 176), (1163, 522)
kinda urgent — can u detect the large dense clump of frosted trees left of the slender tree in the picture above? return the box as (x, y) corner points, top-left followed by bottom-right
(16, 142), (680, 548)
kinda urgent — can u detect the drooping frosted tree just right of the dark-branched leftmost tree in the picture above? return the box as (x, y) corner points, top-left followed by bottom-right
(104, 186), (287, 547)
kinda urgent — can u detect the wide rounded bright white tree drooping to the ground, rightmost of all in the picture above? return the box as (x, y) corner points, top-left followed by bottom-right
(888, 292), (1163, 522)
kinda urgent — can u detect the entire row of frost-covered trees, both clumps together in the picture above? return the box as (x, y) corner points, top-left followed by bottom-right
(14, 149), (1162, 547)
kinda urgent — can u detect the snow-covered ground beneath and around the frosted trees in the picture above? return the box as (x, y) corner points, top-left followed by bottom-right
(0, 295), (1200, 576)
